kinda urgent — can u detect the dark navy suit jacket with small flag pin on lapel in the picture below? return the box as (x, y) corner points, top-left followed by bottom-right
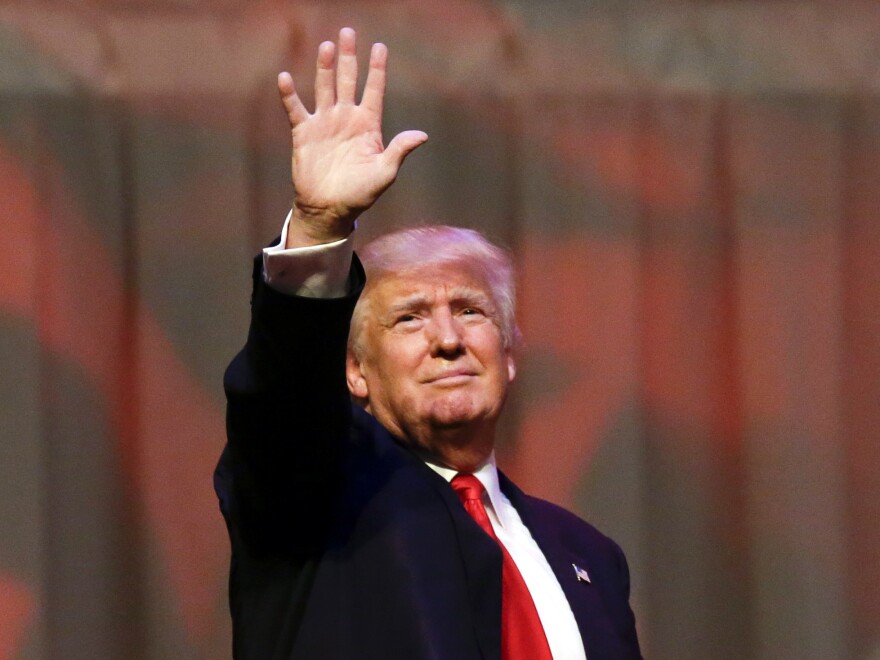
(215, 254), (640, 660)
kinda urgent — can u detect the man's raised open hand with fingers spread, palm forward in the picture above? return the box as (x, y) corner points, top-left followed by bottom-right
(278, 28), (428, 247)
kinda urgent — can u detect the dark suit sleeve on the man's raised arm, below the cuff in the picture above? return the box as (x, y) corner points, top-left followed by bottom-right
(215, 250), (365, 553)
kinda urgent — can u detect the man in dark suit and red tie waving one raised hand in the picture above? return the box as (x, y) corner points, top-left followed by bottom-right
(215, 28), (640, 660)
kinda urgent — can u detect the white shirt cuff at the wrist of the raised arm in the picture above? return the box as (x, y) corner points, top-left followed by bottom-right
(263, 213), (354, 298)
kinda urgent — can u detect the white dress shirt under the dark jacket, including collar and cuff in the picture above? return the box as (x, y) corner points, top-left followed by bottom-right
(263, 214), (586, 660)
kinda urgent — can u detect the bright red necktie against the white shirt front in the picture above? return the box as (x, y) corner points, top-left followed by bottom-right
(452, 474), (553, 660)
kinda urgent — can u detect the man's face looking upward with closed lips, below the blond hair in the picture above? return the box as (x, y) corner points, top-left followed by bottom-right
(347, 263), (515, 449)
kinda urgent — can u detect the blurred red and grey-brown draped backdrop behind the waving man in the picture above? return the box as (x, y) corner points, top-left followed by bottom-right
(0, 0), (880, 660)
